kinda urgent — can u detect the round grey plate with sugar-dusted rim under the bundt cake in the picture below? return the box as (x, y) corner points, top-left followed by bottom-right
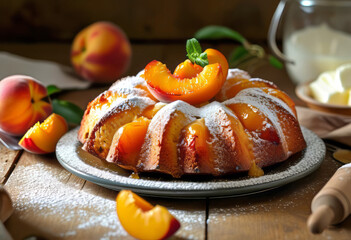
(56, 128), (326, 198)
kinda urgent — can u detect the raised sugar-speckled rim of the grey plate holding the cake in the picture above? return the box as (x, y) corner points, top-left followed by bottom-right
(56, 127), (326, 199)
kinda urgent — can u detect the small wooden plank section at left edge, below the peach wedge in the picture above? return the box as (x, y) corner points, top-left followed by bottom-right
(0, 143), (21, 184)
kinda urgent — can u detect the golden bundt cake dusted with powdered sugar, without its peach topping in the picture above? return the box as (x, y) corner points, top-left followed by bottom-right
(78, 66), (306, 178)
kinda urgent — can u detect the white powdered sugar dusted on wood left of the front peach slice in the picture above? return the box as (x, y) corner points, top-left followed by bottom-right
(7, 161), (127, 239)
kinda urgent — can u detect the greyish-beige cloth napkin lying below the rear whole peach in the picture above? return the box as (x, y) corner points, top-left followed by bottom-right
(0, 52), (90, 89)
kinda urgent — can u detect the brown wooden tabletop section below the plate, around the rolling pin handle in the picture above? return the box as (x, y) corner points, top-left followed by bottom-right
(208, 155), (351, 240)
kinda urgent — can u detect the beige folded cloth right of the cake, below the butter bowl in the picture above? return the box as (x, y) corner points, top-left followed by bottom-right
(296, 107), (351, 146)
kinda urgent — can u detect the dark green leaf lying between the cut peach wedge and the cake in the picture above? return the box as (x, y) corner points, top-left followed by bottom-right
(52, 99), (84, 125)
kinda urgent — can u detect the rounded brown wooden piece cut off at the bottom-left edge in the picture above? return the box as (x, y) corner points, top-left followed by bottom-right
(0, 185), (13, 240)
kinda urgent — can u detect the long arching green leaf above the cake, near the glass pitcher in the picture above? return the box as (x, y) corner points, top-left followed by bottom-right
(195, 25), (247, 43)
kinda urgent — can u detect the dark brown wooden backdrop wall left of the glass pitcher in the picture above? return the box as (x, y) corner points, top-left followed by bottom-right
(0, 0), (279, 42)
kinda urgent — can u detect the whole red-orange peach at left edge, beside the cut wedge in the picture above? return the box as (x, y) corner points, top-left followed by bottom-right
(0, 75), (52, 136)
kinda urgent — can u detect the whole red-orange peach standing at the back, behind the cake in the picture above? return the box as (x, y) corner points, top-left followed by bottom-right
(71, 22), (132, 83)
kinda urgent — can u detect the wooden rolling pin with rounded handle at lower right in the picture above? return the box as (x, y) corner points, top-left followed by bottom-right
(307, 163), (351, 234)
